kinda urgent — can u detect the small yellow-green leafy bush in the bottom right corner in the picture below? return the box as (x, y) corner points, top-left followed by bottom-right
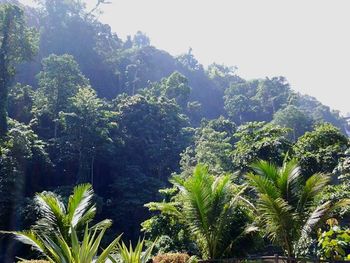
(318, 221), (350, 261)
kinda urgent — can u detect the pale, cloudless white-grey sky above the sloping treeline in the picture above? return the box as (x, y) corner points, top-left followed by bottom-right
(21, 0), (350, 114)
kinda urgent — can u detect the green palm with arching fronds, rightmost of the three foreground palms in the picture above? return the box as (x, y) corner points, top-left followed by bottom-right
(247, 160), (349, 258)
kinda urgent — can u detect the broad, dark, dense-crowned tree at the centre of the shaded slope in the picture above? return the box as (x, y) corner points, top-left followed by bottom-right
(116, 95), (188, 181)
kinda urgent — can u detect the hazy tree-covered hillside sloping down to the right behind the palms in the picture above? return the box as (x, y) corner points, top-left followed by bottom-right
(0, 0), (349, 258)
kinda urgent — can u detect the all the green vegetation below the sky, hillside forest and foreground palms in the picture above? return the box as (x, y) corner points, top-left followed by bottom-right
(0, 0), (350, 262)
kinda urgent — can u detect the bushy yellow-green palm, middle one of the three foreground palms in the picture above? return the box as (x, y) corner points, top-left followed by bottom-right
(147, 165), (253, 259)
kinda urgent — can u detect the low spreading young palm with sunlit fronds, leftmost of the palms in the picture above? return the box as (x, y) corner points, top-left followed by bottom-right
(2, 184), (120, 263)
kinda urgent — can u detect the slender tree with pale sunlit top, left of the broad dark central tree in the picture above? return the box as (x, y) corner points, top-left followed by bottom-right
(58, 87), (115, 183)
